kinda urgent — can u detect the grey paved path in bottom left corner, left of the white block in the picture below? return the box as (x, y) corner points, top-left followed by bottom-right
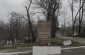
(0, 48), (32, 55)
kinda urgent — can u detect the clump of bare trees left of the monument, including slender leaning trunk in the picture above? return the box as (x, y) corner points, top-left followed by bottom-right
(0, 0), (36, 44)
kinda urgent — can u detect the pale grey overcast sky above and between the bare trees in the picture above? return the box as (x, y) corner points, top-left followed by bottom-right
(0, 0), (79, 26)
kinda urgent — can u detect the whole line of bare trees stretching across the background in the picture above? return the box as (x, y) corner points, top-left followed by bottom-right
(0, 0), (85, 43)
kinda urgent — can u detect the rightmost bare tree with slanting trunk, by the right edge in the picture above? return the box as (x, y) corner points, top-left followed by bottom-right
(73, 0), (85, 35)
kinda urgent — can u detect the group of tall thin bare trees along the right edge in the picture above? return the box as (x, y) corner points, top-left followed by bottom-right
(68, 0), (85, 35)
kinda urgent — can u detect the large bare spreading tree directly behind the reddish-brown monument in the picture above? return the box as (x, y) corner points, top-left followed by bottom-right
(36, 0), (61, 37)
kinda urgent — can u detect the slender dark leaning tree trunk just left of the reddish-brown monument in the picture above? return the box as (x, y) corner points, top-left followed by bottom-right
(25, 0), (35, 42)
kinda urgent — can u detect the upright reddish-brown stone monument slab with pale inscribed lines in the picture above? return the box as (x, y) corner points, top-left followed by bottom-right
(37, 21), (51, 45)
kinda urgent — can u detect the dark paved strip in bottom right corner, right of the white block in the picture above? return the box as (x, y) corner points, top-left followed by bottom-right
(59, 48), (85, 55)
